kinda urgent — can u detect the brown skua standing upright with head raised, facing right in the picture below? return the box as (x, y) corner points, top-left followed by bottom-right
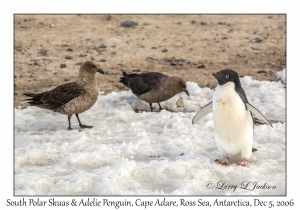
(24, 61), (104, 130)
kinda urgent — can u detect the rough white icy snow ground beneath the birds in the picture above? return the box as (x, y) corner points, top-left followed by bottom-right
(14, 75), (286, 195)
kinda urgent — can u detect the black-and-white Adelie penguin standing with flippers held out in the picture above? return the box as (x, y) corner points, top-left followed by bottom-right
(192, 69), (273, 166)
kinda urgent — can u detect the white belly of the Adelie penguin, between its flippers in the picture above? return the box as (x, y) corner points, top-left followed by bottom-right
(213, 82), (253, 159)
